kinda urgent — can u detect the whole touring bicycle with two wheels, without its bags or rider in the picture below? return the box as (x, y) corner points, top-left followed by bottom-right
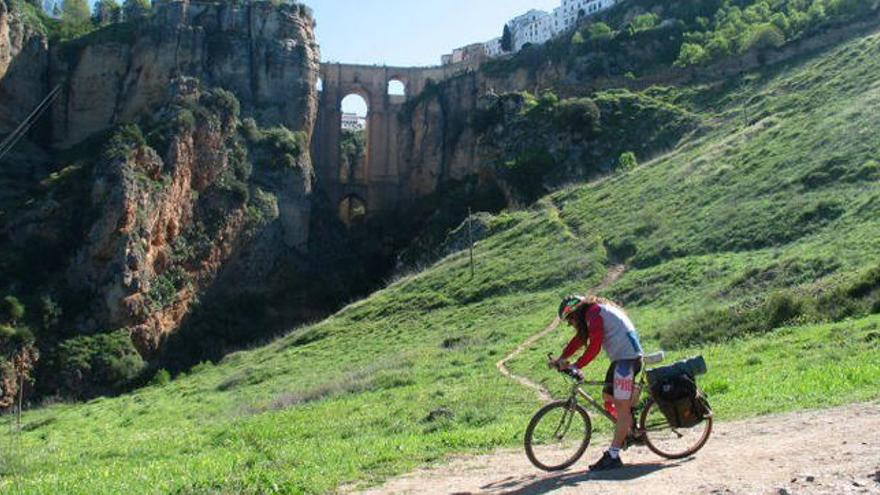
(525, 353), (712, 471)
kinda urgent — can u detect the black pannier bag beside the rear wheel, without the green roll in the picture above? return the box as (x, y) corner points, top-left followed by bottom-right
(651, 373), (712, 428)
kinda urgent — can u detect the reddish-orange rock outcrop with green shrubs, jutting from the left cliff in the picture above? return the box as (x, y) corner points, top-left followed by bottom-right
(66, 87), (312, 357)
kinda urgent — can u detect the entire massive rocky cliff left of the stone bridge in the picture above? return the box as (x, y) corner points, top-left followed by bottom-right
(0, 0), (322, 407)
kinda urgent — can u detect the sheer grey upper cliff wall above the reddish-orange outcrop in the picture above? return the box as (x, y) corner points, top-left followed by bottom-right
(51, 1), (320, 147)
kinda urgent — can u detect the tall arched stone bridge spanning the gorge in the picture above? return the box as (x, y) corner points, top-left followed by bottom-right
(312, 64), (462, 225)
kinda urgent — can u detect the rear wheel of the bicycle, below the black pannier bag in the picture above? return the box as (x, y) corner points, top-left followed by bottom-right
(639, 399), (712, 459)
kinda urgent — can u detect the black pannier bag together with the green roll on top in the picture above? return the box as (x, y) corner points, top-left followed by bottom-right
(648, 356), (712, 428)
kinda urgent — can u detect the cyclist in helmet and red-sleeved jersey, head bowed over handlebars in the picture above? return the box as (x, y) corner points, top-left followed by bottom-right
(550, 295), (644, 471)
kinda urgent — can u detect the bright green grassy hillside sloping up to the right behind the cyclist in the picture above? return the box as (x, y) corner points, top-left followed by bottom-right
(0, 21), (880, 493)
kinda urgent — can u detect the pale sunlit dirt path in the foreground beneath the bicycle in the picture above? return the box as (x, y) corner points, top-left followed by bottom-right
(350, 403), (880, 495)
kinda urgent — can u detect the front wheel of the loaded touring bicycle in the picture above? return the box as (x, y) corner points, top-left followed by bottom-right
(525, 401), (593, 471)
